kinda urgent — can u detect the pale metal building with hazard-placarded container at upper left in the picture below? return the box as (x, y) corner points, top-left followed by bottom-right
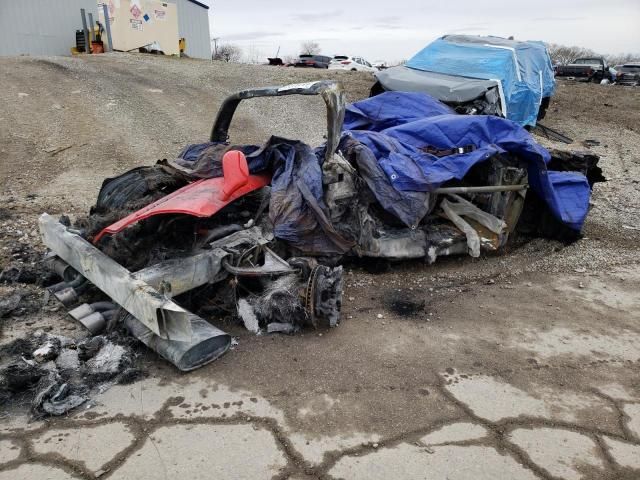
(0, 0), (211, 59)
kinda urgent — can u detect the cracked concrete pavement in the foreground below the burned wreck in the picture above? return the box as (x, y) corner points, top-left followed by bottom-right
(0, 268), (640, 480)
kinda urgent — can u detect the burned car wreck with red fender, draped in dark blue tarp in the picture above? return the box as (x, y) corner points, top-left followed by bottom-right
(40, 81), (598, 371)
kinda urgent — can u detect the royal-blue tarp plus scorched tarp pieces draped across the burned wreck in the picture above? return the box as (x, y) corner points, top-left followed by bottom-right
(175, 92), (591, 255)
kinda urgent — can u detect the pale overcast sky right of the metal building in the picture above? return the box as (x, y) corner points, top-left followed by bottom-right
(200, 0), (640, 61)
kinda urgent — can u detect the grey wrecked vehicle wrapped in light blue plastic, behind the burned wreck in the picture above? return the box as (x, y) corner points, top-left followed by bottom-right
(371, 35), (555, 127)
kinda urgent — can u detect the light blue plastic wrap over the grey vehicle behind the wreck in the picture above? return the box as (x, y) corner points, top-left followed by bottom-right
(406, 35), (555, 126)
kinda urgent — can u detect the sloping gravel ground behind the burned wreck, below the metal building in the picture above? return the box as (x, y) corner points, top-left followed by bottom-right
(0, 54), (371, 214)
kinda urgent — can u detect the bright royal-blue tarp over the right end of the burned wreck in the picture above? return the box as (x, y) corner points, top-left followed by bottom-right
(344, 92), (591, 231)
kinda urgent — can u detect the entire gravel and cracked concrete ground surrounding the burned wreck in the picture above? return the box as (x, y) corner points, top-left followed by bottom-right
(0, 54), (640, 479)
